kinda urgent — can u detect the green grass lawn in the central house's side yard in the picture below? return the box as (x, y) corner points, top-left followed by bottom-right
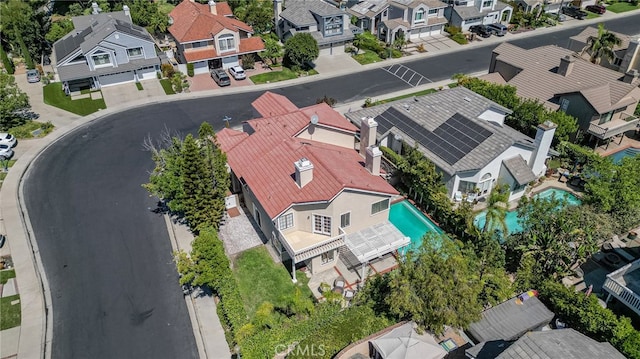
(234, 246), (313, 317)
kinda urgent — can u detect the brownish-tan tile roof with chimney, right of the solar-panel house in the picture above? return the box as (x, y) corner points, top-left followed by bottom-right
(487, 43), (640, 114)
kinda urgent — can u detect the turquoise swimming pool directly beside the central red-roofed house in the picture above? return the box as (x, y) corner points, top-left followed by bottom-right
(389, 200), (444, 249)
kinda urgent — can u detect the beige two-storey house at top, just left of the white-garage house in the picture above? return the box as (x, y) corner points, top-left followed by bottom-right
(347, 0), (448, 43)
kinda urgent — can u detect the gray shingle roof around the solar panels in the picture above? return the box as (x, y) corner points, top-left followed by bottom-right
(345, 86), (534, 175)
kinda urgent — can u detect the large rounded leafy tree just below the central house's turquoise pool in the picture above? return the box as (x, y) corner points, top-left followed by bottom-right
(386, 235), (482, 333)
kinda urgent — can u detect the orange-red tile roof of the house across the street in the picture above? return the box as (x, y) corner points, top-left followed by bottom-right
(169, 0), (253, 42)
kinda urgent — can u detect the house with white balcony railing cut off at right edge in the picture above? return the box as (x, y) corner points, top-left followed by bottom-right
(602, 259), (640, 316)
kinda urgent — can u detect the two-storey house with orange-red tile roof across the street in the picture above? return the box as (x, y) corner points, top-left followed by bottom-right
(169, 0), (264, 73)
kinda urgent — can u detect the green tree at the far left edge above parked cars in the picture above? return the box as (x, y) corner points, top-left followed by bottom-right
(0, 70), (31, 131)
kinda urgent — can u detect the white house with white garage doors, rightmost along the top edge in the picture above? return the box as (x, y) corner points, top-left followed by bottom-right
(444, 0), (513, 31)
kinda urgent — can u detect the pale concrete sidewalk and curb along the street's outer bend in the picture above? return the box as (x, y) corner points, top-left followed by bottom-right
(0, 10), (640, 359)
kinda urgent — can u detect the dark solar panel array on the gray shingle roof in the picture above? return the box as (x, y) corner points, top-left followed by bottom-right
(379, 107), (492, 165)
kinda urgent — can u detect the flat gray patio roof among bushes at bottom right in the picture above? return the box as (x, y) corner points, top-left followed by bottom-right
(469, 297), (554, 342)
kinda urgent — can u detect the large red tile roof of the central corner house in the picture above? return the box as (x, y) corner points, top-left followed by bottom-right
(217, 93), (398, 218)
